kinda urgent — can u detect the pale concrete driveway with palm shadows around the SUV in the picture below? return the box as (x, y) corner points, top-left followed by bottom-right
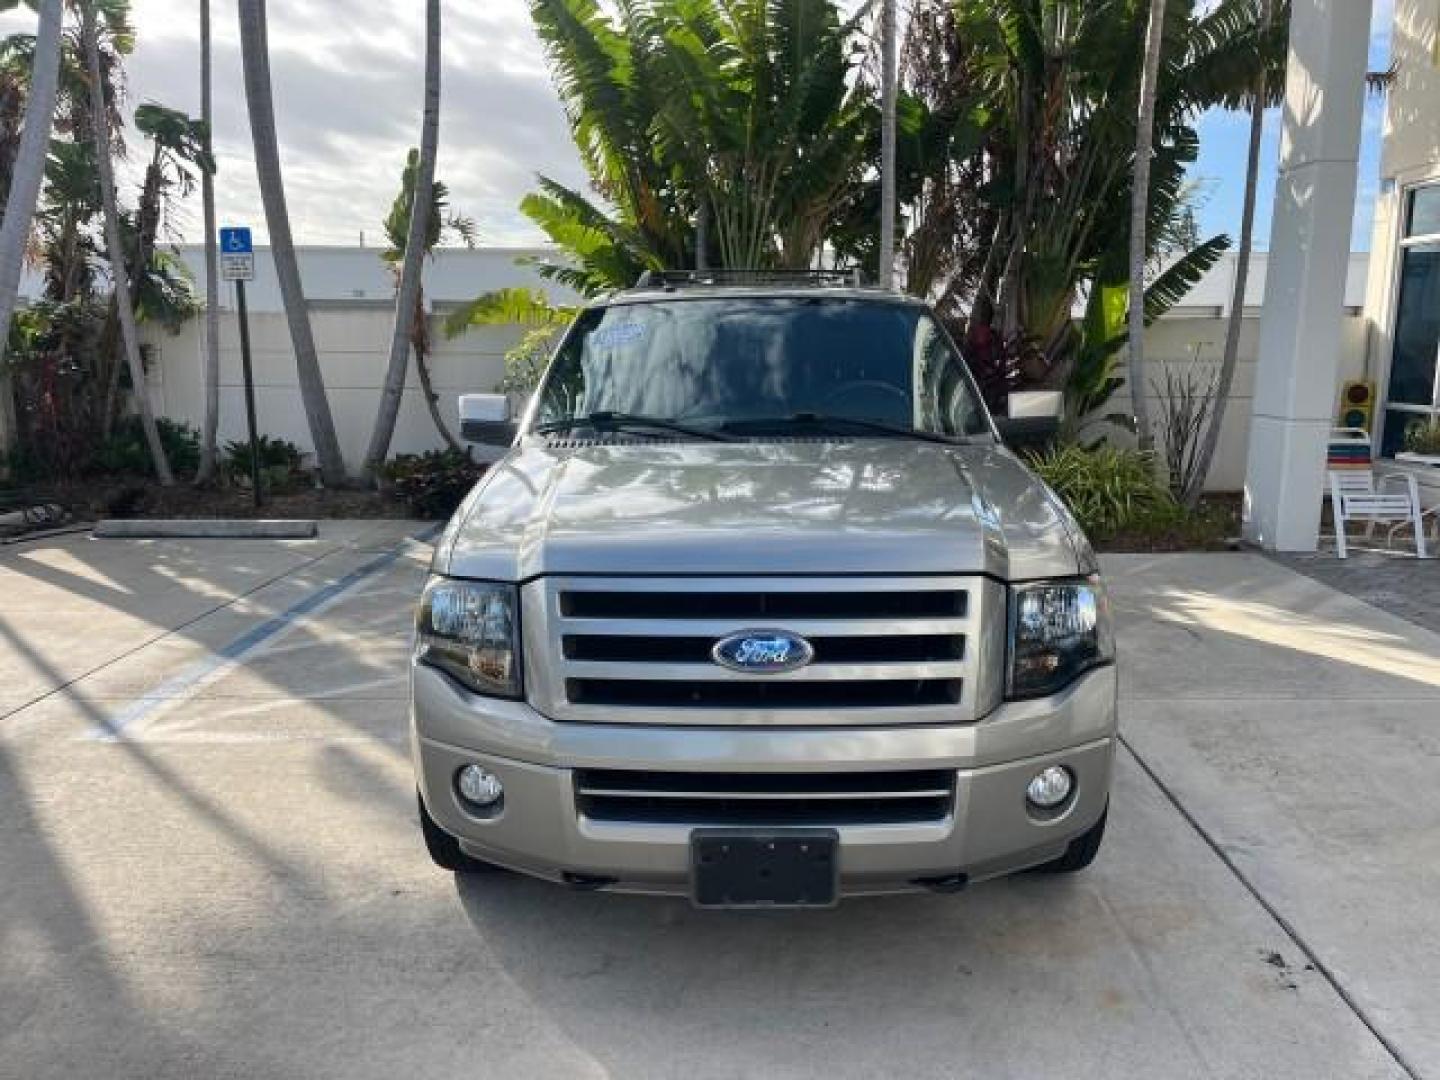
(0, 523), (1440, 1080)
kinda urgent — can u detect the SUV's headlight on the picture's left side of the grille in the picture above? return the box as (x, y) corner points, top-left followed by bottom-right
(415, 577), (520, 697)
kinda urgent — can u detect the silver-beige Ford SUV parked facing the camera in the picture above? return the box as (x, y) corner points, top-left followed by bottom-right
(410, 275), (1116, 907)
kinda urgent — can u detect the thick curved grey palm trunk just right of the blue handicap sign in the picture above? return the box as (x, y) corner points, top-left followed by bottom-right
(238, 0), (346, 487)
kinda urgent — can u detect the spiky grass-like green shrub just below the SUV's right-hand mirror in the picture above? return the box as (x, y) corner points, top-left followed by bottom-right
(1030, 445), (1179, 536)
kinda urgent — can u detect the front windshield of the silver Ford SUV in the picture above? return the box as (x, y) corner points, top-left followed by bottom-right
(533, 297), (991, 436)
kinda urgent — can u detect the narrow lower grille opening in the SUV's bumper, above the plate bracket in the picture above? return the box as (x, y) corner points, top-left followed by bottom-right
(575, 769), (955, 825)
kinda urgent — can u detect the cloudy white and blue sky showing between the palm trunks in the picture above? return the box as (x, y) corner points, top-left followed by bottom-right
(0, 0), (1392, 249)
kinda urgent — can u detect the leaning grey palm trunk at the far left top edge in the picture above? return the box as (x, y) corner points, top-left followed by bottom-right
(0, 0), (65, 361)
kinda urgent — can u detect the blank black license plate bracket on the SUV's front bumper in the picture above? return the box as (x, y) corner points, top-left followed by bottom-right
(690, 828), (840, 907)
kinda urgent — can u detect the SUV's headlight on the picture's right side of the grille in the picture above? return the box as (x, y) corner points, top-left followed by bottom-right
(1007, 577), (1115, 698)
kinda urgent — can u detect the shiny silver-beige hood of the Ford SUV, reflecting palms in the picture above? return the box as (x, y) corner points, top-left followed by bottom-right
(435, 438), (1089, 580)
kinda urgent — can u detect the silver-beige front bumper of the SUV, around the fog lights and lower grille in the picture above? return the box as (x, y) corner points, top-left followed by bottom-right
(410, 665), (1116, 896)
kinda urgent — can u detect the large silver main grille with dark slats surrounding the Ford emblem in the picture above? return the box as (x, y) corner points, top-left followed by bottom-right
(523, 576), (1004, 726)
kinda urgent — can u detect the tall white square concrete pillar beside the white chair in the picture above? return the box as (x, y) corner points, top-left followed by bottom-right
(1246, 0), (1371, 552)
